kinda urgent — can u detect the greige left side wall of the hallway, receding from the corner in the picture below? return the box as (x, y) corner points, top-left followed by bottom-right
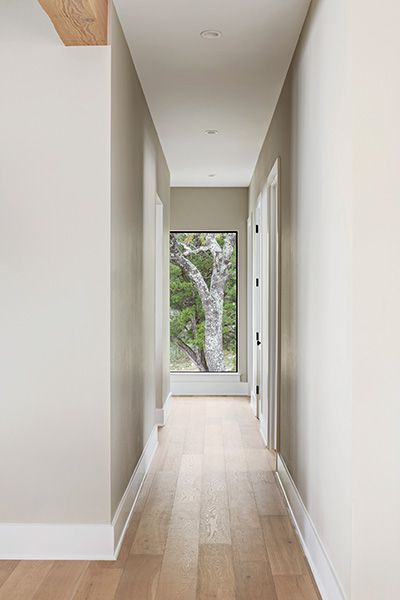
(111, 9), (169, 517)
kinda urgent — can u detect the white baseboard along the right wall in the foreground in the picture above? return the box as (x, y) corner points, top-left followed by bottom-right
(277, 455), (346, 600)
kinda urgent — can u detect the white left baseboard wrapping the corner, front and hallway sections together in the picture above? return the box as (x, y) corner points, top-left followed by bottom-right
(0, 426), (158, 560)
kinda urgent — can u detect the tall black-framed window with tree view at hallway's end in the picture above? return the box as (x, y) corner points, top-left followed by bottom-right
(170, 231), (238, 373)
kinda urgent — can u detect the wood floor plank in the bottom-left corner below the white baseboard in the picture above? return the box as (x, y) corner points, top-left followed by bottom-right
(0, 560), (54, 600)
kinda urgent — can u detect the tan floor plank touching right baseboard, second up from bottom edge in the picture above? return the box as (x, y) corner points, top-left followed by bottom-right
(261, 516), (307, 575)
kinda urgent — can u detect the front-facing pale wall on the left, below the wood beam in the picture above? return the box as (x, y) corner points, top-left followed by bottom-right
(0, 0), (110, 523)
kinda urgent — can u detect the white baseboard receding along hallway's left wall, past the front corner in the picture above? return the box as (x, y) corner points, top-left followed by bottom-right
(112, 425), (158, 558)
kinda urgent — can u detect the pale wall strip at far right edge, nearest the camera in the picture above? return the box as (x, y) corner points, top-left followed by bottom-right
(351, 0), (400, 600)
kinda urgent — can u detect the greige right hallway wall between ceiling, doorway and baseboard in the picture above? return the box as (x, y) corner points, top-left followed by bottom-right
(249, 0), (352, 595)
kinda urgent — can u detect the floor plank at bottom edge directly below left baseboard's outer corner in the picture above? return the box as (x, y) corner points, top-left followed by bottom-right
(72, 563), (123, 600)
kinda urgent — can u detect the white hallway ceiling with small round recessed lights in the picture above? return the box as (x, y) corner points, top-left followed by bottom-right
(114, 0), (310, 186)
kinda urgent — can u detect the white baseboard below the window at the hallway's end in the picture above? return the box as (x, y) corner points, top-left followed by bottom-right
(171, 373), (249, 396)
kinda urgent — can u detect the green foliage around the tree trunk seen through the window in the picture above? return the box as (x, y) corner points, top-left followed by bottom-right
(170, 233), (237, 370)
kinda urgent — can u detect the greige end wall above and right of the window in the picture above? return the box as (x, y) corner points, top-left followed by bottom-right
(171, 187), (248, 381)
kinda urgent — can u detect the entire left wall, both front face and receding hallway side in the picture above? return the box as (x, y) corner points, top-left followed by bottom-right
(0, 0), (169, 523)
